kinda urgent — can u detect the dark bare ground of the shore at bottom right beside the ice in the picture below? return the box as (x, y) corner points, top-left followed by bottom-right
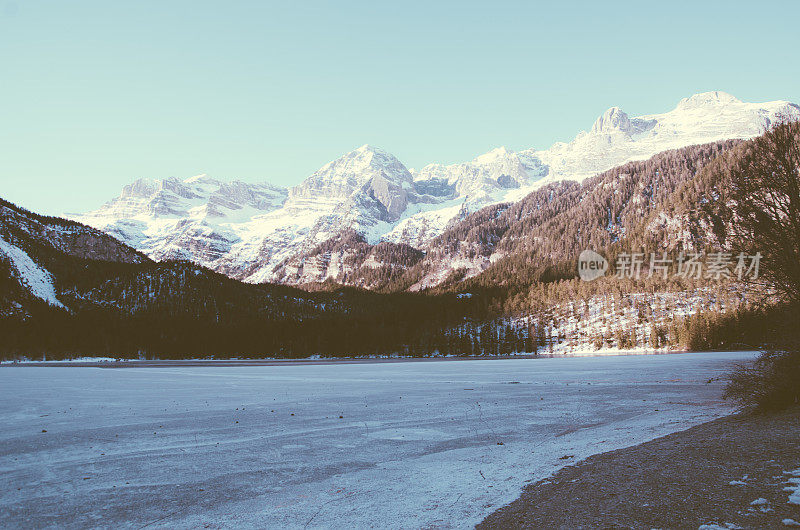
(478, 408), (800, 529)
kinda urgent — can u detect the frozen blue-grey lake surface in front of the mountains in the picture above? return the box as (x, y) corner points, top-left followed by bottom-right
(0, 353), (754, 528)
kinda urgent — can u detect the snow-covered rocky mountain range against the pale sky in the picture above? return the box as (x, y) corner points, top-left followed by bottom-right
(68, 92), (800, 283)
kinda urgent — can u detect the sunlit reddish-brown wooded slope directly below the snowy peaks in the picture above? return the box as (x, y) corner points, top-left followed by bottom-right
(290, 140), (743, 291)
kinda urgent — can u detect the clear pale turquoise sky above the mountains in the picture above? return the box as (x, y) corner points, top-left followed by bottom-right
(0, 0), (800, 214)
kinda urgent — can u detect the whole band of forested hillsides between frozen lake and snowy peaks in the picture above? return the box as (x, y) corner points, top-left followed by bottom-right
(0, 127), (792, 358)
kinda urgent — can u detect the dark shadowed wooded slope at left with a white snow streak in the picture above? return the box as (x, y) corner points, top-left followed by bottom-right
(0, 194), (504, 360)
